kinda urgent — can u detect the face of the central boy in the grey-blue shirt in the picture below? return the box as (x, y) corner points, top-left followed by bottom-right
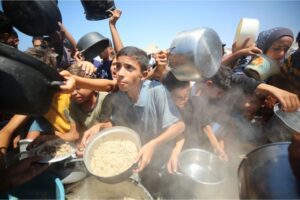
(115, 56), (144, 92)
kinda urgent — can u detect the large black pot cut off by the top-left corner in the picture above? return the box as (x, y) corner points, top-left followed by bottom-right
(2, 0), (62, 36)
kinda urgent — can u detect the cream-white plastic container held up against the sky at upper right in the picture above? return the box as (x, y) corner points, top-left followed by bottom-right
(234, 18), (259, 48)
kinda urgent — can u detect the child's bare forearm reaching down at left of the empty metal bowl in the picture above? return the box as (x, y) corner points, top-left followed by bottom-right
(167, 134), (185, 174)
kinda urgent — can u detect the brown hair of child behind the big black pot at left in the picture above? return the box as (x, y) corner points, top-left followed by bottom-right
(25, 48), (56, 69)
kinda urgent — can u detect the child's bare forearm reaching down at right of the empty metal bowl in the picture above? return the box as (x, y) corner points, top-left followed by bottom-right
(203, 125), (228, 161)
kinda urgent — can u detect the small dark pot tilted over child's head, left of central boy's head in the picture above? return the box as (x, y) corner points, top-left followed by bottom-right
(77, 32), (109, 60)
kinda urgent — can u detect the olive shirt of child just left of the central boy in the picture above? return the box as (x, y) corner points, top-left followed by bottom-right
(70, 92), (108, 133)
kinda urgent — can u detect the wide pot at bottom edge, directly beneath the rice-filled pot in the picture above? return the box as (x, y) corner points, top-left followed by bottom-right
(66, 176), (153, 200)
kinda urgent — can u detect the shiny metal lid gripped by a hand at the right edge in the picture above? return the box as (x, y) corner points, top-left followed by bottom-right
(273, 103), (300, 133)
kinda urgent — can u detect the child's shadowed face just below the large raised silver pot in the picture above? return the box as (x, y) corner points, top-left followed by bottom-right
(171, 86), (190, 110)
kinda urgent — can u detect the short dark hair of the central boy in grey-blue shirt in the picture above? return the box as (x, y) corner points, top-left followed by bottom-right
(117, 46), (149, 72)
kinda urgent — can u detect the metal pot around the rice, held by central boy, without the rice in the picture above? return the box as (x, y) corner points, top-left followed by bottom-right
(83, 126), (141, 183)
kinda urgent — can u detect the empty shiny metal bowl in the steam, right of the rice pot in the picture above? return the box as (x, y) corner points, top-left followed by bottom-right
(178, 149), (226, 185)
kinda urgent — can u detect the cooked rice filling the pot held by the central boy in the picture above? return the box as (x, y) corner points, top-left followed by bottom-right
(91, 140), (138, 177)
